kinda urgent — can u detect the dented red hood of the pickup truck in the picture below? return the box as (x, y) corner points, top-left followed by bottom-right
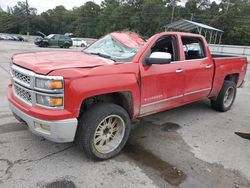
(12, 51), (114, 74)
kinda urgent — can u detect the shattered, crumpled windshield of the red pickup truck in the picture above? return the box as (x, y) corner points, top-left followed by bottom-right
(84, 35), (139, 60)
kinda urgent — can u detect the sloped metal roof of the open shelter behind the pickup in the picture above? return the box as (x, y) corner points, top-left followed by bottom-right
(165, 19), (223, 33)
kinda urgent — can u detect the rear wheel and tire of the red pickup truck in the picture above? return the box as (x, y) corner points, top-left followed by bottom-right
(211, 81), (237, 112)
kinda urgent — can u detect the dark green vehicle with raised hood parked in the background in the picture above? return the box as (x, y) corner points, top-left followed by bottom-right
(34, 32), (72, 48)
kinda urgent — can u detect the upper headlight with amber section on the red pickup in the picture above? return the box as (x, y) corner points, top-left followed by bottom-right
(35, 78), (63, 90)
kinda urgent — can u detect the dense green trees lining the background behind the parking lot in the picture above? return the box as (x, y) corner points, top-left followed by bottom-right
(0, 0), (250, 45)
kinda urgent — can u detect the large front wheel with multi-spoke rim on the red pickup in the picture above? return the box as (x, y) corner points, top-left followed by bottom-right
(76, 103), (130, 160)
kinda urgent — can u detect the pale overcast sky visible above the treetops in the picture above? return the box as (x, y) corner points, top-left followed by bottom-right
(0, 0), (220, 13)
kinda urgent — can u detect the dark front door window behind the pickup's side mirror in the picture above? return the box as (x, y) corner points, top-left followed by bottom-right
(151, 36), (179, 61)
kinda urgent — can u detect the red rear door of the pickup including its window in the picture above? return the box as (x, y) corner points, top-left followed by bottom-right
(181, 36), (214, 102)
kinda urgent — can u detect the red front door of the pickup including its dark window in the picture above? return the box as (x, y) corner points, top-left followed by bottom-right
(140, 36), (185, 115)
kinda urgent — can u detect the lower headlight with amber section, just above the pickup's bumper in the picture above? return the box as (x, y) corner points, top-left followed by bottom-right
(36, 94), (63, 107)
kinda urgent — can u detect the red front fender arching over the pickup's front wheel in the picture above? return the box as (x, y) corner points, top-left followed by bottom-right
(71, 74), (140, 117)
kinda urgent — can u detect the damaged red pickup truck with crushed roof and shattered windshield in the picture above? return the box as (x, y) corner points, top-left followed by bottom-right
(8, 32), (247, 160)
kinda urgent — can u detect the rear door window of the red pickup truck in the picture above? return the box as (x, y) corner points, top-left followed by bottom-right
(181, 37), (206, 60)
